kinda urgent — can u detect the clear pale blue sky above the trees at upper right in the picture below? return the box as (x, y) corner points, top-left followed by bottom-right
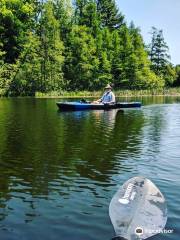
(116, 0), (180, 65)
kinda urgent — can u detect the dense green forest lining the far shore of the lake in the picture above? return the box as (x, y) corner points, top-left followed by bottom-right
(0, 0), (180, 96)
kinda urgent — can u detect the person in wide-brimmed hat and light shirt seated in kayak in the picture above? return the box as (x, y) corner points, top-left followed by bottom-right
(93, 84), (116, 104)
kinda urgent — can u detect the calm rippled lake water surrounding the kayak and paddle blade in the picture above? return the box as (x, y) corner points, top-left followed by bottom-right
(0, 97), (180, 240)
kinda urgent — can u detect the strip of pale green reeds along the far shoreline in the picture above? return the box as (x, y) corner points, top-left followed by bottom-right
(35, 87), (180, 98)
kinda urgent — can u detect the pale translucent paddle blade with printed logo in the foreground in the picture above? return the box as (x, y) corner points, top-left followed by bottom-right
(109, 177), (167, 240)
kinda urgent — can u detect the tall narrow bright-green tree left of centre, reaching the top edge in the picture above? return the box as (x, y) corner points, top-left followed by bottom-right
(39, 1), (64, 91)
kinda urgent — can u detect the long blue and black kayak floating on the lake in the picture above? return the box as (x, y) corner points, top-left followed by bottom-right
(56, 102), (141, 111)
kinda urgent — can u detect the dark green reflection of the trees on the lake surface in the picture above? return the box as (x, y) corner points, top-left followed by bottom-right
(0, 101), (144, 221)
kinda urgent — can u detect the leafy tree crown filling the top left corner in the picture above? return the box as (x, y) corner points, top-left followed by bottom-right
(0, 0), (34, 63)
